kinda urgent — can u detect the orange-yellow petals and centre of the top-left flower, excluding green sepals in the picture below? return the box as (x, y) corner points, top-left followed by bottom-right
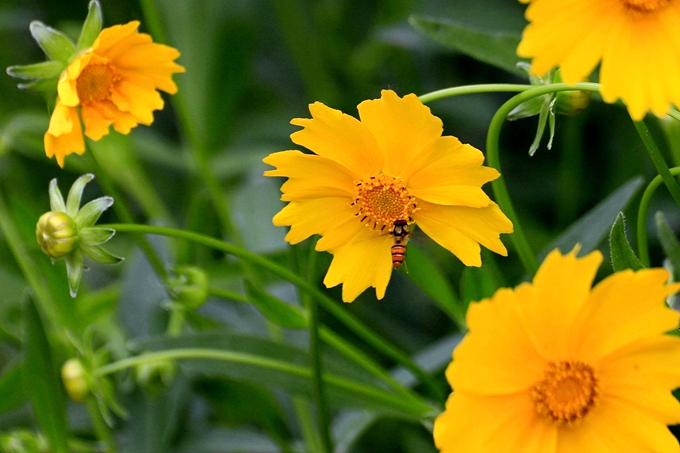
(45, 21), (184, 167)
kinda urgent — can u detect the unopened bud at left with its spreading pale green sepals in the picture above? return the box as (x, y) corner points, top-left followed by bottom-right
(35, 174), (123, 297)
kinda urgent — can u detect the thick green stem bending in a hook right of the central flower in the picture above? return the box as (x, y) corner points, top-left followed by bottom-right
(486, 83), (599, 275)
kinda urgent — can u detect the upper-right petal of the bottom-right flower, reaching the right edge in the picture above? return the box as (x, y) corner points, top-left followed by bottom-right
(572, 269), (678, 361)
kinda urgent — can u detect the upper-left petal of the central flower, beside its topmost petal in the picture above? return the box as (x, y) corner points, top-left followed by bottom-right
(290, 102), (383, 180)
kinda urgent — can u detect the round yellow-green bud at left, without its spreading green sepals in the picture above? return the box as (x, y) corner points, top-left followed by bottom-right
(35, 211), (79, 259)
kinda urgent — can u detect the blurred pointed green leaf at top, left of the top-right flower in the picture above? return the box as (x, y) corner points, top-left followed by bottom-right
(409, 16), (526, 77)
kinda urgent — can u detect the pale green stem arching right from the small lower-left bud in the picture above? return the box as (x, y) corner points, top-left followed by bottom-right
(94, 348), (434, 417)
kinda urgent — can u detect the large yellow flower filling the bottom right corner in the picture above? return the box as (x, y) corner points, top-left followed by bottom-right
(434, 250), (680, 453)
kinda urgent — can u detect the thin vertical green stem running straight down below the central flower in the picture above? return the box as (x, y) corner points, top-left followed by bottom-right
(304, 241), (333, 453)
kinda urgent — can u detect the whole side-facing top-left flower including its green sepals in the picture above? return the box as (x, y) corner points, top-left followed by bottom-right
(7, 0), (184, 167)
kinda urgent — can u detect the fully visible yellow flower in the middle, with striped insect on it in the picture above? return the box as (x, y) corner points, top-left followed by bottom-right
(264, 90), (512, 302)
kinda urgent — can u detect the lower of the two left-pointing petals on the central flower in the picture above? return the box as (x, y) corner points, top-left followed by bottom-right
(273, 197), (355, 244)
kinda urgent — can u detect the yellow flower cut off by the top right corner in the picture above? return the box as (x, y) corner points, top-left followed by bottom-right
(517, 0), (680, 120)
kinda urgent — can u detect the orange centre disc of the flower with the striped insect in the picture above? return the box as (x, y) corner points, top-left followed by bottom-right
(352, 174), (417, 228)
